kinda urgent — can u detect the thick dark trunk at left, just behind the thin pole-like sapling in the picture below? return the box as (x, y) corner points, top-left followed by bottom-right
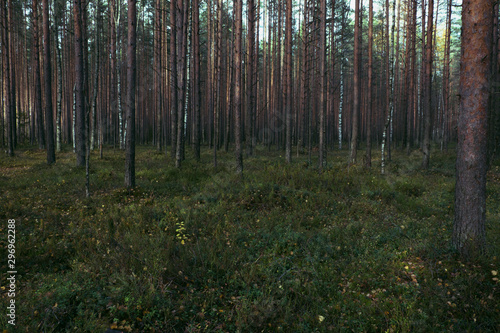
(73, 0), (86, 167)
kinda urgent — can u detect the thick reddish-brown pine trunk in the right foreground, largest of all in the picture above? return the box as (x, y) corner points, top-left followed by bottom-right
(454, 0), (496, 256)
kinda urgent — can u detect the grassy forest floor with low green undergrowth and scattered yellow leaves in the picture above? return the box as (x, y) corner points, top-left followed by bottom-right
(0, 147), (500, 333)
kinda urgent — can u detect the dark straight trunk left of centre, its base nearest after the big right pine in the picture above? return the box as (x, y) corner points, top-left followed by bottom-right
(125, 0), (137, 188)
